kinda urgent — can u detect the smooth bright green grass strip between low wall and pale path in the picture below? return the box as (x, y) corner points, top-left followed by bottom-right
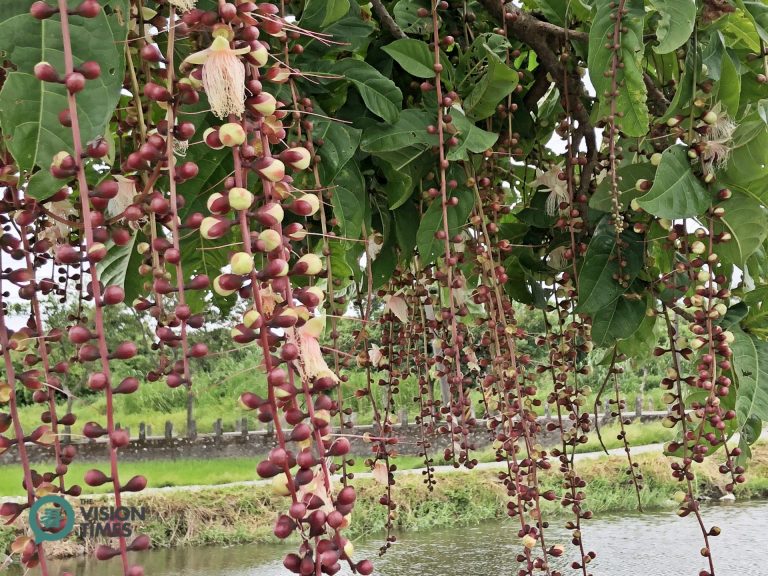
(0, 422), (673, 497)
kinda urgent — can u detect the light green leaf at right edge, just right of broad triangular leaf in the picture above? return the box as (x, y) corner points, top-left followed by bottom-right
(714, 191), (768, 267)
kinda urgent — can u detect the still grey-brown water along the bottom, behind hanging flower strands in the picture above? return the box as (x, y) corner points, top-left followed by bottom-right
(12, 502), (768, 576)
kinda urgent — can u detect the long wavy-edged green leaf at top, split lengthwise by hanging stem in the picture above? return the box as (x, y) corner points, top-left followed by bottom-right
(587, 0), (649, 136)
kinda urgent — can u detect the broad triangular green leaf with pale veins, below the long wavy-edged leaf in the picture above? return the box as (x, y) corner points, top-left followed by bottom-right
(637, 146), (710, 219)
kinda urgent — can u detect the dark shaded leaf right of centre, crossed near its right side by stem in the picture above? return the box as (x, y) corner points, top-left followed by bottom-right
(576, 216), (643, 314)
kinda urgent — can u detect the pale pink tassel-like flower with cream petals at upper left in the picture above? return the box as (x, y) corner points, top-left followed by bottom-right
(184, 36), (250, 118)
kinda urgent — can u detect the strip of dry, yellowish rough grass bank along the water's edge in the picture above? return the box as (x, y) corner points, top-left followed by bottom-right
(0, 444), (768, 554)
